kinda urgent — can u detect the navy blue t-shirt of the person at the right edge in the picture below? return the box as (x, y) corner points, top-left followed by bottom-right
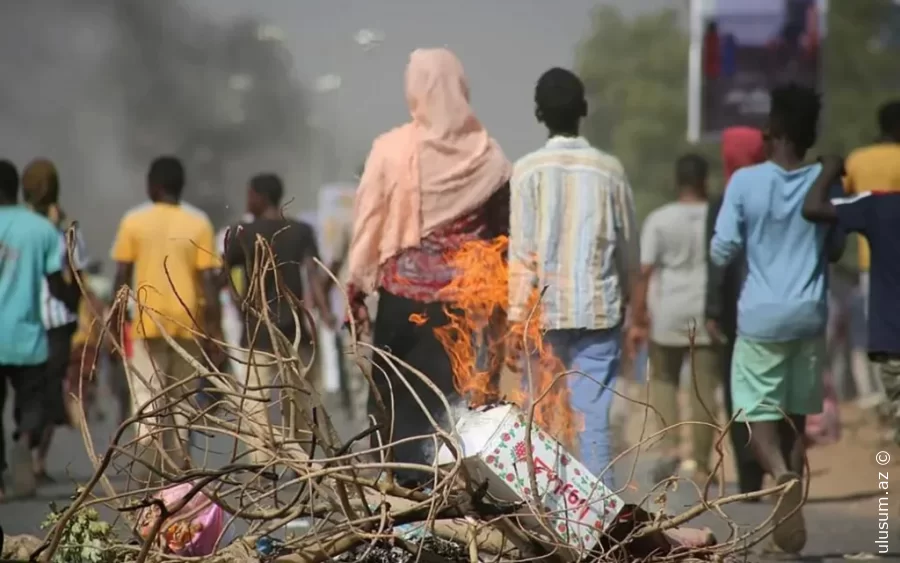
(831, 192), (900, 356)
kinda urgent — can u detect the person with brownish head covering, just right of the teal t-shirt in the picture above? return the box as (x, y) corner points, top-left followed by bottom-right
(22, 159), (87, 482)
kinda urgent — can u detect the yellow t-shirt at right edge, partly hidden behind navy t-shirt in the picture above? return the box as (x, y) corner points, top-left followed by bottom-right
(844, 143), (900, 271)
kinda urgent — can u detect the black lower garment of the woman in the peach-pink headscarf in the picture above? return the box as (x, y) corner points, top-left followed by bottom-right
(368, 291), (459, 487)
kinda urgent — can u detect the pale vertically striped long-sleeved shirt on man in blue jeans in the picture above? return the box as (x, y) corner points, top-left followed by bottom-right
(509, 137), (640, 330)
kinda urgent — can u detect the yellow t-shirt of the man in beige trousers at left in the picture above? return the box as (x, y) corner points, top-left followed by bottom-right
(112, 203), (219, 339)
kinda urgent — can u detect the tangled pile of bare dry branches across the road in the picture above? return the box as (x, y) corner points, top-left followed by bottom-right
(28, 247), (800, 563)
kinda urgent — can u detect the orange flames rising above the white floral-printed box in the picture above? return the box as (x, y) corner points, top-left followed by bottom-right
(409, 236), (581, 447)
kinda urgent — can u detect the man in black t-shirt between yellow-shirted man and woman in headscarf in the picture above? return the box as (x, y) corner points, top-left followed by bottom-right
(225, 174), (336, 463)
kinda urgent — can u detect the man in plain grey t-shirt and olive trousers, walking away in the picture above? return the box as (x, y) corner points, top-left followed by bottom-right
(629, 154), (719, 485)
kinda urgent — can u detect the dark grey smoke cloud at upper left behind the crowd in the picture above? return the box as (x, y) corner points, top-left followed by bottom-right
(0, 0), (312, 249)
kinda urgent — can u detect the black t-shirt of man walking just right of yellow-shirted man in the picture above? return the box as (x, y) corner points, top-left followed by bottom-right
(225, 219), (319, 352)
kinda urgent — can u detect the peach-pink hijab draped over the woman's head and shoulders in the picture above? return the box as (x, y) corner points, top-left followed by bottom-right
(348, 49), (511, 292)
